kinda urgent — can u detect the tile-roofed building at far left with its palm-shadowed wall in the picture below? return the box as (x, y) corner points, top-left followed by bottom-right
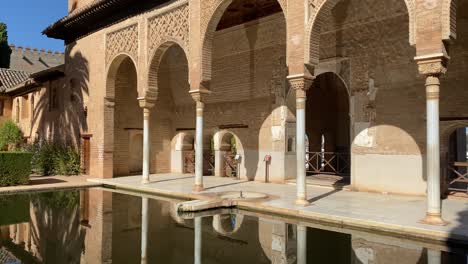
(0, 45), (71, 144)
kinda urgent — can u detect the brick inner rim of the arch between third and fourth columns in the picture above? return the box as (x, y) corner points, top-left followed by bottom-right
(304, 0), (416, 65)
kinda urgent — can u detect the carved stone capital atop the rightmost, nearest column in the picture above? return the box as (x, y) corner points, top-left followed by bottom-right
(414, 53), (450, 76)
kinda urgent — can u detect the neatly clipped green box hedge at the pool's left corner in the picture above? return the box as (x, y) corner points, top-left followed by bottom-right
(0, 152), (32, 186)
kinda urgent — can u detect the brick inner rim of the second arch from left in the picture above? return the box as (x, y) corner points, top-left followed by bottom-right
(148, 38), (188, 95)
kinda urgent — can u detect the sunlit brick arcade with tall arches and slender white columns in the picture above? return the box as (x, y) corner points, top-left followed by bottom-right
(48, 0), (468, 223)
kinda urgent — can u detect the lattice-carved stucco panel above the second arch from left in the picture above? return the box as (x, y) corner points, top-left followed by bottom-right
(148, 4), (189, 55)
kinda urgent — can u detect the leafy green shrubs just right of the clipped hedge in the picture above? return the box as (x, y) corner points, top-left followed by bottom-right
(26, 142), (81, 176)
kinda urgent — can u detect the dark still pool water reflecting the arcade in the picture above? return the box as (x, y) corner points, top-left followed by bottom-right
(0, 189), (468, 264)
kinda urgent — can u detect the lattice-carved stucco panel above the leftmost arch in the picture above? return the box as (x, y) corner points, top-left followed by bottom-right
(106, 24), (138, 65)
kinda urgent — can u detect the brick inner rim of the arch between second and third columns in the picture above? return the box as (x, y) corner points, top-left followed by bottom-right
(200, 0), (286, 88)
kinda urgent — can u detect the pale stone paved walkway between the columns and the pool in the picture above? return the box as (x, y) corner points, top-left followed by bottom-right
(89, 174), (468, 243)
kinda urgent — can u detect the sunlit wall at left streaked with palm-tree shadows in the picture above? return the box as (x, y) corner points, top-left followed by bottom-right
(11, 78), (87, 146)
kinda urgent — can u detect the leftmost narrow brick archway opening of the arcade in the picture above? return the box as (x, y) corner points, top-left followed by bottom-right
(104, 54), (143, 177)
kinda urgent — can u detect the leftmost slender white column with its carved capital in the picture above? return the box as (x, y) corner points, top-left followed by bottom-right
(138, 97), (156, 183)
